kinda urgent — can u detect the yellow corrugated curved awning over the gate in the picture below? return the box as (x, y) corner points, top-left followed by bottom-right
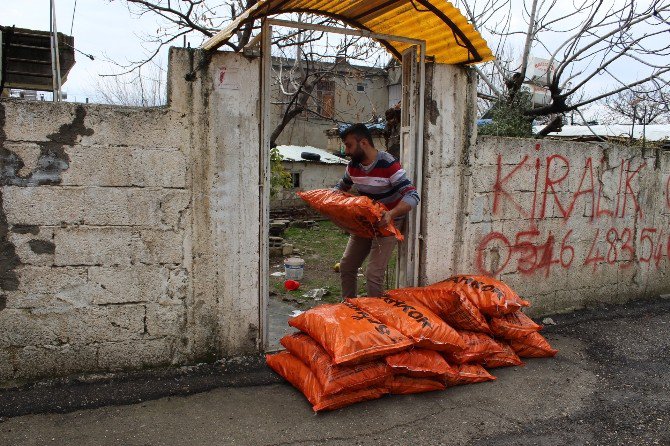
(202, 0), (494, 65)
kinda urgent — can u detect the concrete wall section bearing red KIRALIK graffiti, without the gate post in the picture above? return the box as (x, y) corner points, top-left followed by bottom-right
(464, 137), (670, 314)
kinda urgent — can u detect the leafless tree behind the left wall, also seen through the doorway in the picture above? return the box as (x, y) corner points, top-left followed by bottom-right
(111, 0), (385, 145)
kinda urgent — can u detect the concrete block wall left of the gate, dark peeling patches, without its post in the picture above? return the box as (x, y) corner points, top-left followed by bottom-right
(0, 101), (191, 384)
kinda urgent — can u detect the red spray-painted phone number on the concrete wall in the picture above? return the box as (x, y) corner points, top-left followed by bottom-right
(477, 228), (670, 277)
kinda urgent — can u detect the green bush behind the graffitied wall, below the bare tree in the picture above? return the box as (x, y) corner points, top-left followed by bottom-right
(484, 91), (533, 138)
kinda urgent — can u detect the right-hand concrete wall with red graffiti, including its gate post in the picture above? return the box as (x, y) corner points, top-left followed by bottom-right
(420, 65), (670, 315)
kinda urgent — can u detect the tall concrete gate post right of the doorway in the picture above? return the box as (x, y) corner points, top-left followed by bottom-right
(419, 64), (477, 285)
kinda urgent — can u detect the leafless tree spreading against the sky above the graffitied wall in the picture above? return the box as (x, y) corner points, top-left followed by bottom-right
(456, 0), (670, 132)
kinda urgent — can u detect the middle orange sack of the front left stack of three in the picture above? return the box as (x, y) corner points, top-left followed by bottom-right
(279, 333), (391, 395)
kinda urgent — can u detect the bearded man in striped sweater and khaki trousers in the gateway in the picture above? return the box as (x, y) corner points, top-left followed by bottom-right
(335, 124), (419, 298)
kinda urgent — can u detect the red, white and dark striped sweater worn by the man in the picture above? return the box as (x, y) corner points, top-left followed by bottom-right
(335, 151), (419, 209)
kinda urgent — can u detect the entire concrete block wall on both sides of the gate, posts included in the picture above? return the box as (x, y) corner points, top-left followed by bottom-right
(0, 49), (670, 386)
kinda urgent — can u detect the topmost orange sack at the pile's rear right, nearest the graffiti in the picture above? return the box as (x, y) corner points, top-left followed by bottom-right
(429, 275), (530, 316)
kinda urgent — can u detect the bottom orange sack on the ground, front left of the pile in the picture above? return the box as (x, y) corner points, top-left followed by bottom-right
(265, 351), (388, 412)
